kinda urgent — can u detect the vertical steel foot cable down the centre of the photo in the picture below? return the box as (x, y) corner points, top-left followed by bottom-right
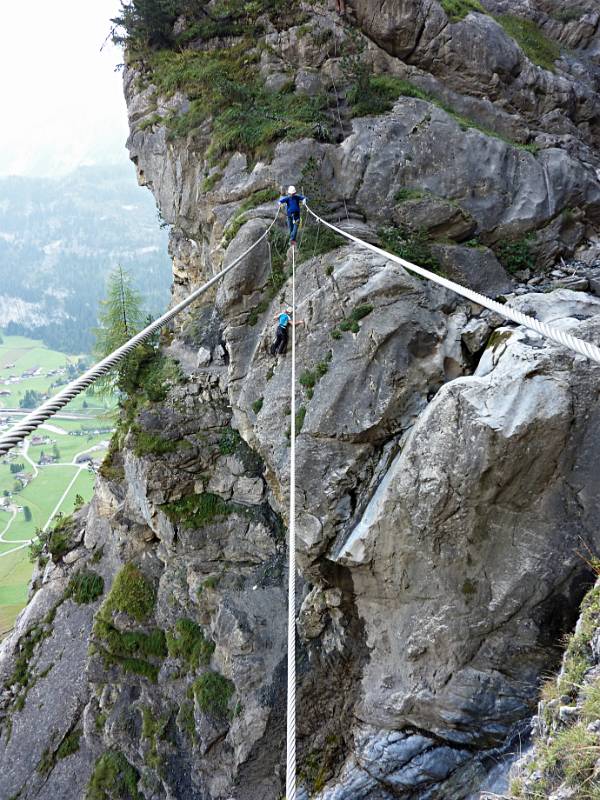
(285, 247), (296, 800)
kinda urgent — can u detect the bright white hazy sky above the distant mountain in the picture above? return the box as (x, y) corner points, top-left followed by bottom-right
(0, 0), (127, 176)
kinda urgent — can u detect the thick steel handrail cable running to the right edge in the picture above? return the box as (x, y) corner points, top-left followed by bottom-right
(306, 205), (600, 364)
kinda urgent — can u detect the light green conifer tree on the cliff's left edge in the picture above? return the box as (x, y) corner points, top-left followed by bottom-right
(94, 266), (143, 395)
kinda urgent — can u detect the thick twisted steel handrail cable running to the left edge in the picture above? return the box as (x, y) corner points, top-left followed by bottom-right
(0, 206), (281, 456)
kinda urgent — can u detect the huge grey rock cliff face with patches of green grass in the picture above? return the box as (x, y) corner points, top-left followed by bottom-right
(0, 0), (600, 800)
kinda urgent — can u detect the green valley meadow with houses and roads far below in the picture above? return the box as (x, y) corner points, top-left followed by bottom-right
(0, 336), (112, 638)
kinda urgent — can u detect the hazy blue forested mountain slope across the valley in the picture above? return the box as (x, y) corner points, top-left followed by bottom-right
(0, 164), (171, 352)
